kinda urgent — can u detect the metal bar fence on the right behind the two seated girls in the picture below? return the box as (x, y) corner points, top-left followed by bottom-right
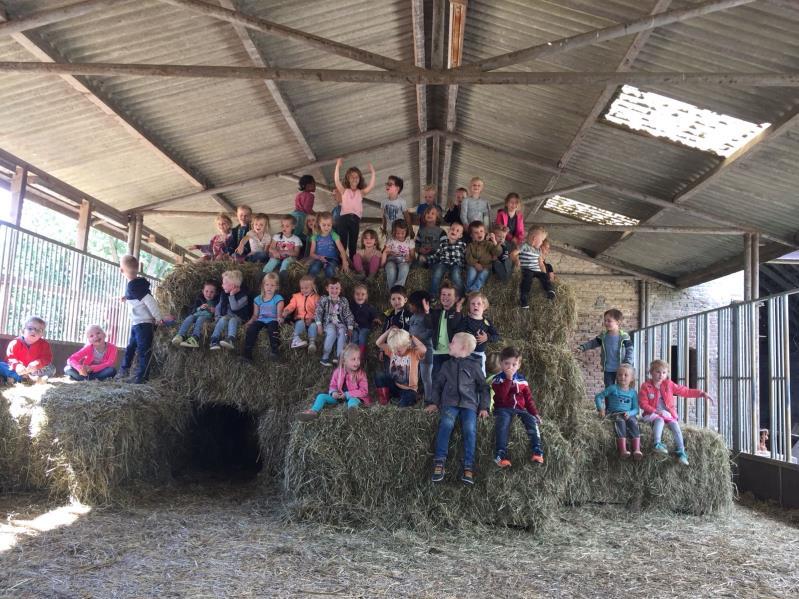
(632, 290), (799, 463)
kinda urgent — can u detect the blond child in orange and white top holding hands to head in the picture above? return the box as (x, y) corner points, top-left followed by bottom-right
(375, 327), (426, 408)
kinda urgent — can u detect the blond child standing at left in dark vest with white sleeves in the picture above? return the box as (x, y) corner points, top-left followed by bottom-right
(117, 255), (162, 384)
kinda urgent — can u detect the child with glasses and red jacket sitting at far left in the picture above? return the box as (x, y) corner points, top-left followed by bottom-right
(0, 316), (55, 383)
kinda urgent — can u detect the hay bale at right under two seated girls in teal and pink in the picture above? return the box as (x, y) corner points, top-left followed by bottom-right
(565, 411), (733, 515)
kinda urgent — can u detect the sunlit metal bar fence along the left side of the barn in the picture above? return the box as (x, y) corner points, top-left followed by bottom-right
(0, 221), (158, 345)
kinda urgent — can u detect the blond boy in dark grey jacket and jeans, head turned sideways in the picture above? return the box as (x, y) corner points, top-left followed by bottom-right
(425, 333), (488, 485)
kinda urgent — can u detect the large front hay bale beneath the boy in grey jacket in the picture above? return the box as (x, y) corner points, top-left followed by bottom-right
(284, 407), (574, 532)
